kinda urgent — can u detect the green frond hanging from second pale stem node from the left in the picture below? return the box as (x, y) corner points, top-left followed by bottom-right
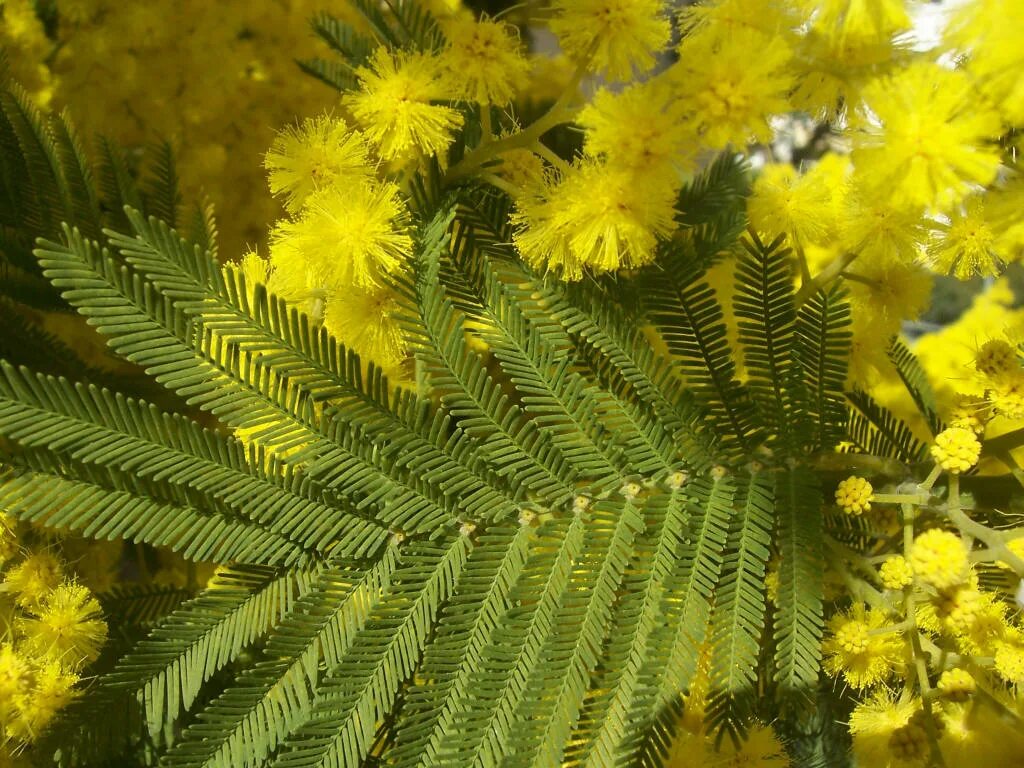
(273, 536), (472, 768)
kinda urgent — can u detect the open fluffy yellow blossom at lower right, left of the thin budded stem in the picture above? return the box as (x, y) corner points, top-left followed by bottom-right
(821, 603), (903, 688)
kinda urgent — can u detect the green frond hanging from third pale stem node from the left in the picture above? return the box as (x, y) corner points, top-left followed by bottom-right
(388, 525), (532, 768)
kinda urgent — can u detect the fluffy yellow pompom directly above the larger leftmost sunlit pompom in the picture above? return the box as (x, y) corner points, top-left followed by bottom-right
(263, 115), (373, 213)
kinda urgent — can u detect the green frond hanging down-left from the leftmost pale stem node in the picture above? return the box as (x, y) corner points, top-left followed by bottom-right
(165, 547), (397, 768)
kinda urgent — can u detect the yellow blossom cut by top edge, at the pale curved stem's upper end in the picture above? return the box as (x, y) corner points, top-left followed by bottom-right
(551, 0), (672, 80)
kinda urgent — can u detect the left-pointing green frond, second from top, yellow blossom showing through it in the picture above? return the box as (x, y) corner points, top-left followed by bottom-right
(30, 225), (460, 530)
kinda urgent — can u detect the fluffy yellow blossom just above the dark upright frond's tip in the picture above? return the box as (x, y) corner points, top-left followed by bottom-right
(746, 163), (833, 244)
